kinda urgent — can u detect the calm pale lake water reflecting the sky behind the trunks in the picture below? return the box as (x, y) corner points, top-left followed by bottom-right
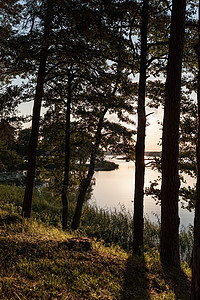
(92, 157), (194, 226)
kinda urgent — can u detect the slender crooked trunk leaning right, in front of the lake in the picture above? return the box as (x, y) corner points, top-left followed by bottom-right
(71, 109), (107, 230)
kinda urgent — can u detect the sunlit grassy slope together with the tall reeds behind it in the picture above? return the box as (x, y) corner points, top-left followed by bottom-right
(0, 186), (191, 300)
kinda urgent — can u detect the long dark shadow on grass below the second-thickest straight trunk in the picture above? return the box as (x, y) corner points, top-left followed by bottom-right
(120, 255), (150, 300)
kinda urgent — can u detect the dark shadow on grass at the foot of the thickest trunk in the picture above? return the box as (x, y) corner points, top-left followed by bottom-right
(162, 265), (190, 300)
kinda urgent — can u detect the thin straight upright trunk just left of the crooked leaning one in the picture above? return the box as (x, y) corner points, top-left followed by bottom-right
(61, 70), (72, 230)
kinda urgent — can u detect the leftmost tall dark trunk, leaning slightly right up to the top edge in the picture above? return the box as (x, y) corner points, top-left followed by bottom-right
(22, 0), (52, 218)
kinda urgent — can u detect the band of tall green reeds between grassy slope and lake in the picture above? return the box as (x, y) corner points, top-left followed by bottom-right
(0, 185), (193, 263)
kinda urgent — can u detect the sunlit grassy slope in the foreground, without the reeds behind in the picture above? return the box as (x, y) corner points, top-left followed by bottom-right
(0, 209), (191, 300)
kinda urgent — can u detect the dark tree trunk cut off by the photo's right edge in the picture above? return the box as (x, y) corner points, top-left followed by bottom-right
(190, 1), (200, 300)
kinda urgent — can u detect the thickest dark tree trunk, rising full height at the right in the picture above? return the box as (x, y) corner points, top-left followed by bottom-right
(160, 0), (186, 267)
